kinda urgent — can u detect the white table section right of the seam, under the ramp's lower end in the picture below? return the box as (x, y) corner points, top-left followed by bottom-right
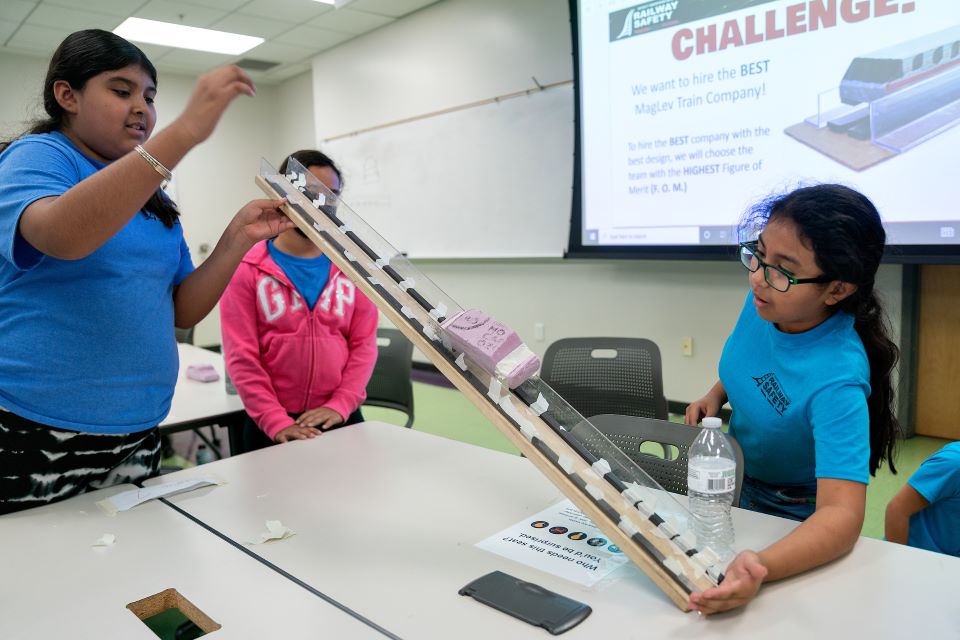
(148, 422), (960, 640)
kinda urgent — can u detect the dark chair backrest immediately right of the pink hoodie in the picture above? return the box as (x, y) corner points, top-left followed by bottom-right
(364, 327), (413, 427)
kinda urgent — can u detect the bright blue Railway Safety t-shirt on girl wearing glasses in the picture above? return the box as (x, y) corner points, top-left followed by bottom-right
(720, 293), (870, 487)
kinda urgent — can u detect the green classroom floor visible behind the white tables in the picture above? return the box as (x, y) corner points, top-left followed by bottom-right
(363, 383), (947, 538)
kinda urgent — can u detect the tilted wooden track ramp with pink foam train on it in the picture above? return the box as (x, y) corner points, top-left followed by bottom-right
(257, 158), (729, 610)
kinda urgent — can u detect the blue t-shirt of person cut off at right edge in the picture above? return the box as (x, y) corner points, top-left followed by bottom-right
(908, 442), (960, 557)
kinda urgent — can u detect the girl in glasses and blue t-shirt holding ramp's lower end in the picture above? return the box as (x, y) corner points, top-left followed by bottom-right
(686, 184), (899, 613)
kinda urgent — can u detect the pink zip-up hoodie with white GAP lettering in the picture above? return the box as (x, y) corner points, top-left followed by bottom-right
(220, 242), (378, 440)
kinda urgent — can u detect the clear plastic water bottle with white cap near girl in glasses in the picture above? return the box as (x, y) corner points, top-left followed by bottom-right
(687, 418), (737, 558)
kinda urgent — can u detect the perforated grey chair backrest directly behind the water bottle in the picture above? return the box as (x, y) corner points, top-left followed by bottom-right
(576, 414), (743, 506)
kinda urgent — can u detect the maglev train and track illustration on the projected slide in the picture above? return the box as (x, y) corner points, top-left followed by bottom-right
(786, 25), (960, 171)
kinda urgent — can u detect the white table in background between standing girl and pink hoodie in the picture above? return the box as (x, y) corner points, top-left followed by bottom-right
(160, 343), (246, 456)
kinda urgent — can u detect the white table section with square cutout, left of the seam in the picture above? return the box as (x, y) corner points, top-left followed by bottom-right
(0, 485), (385, 640)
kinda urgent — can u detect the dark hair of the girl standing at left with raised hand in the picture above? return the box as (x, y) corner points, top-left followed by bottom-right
(0, 29), (180, 227)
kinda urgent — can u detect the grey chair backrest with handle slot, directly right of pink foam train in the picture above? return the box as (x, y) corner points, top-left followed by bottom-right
(540, 338), (668, 420)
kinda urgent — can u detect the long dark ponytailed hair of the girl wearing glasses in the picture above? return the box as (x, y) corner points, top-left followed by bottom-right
(740, 184), (900, 475)
